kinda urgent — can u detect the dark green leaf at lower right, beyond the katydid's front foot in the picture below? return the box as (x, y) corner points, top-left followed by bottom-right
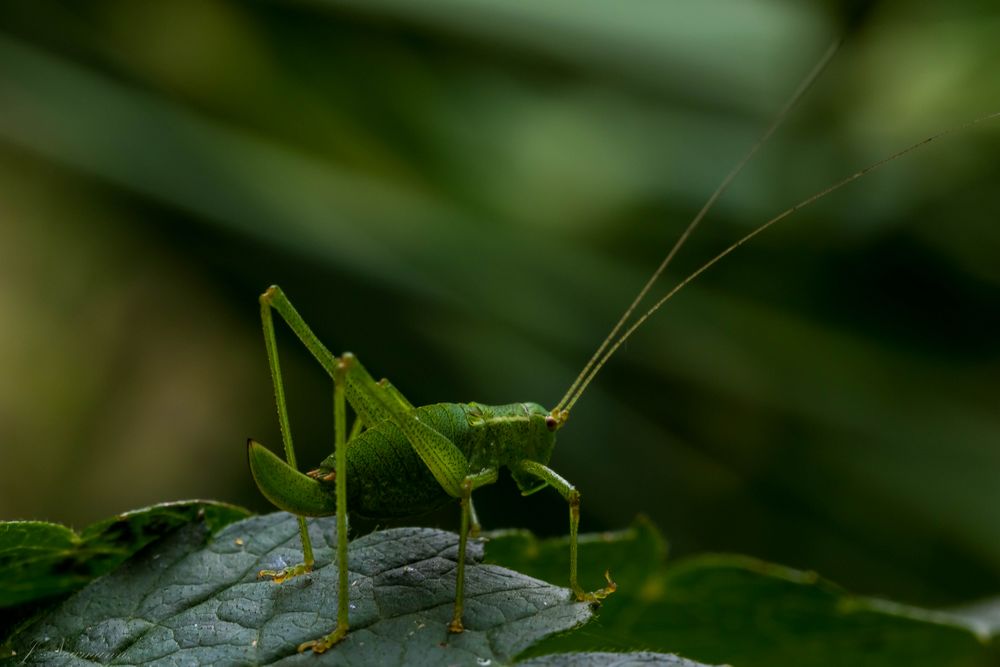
(488, 519), (998, 667)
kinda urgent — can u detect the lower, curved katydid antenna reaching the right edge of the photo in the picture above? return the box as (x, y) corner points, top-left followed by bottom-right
(563, 111), (1000, 412)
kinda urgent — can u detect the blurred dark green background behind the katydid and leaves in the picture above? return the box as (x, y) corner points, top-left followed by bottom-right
(0, 0), (1000, 605)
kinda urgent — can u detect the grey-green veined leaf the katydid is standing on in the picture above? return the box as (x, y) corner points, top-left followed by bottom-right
(3, 513), (592, 665)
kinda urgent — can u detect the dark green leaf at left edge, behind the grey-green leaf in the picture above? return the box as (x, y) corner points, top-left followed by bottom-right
(0, 501), (249, 608)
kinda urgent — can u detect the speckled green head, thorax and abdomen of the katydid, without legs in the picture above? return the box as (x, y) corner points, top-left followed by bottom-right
(320, 403), (555, 519)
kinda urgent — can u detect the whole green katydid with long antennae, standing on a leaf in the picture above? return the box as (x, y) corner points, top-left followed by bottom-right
(248, 36), (1000, 653)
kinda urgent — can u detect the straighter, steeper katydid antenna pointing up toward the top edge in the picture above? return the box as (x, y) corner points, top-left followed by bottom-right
(552, 39), (841, 415)
